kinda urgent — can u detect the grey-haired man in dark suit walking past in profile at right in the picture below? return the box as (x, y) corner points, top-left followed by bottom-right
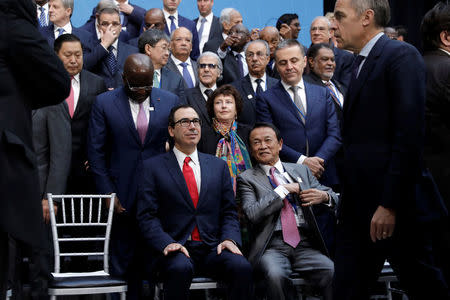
(334, 0), (449, 300)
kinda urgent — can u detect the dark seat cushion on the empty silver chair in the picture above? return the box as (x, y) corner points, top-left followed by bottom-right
(49, 275), (126, 288)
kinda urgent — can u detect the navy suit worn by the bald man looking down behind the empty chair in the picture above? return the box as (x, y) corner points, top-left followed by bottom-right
(88, 88), (179, 297)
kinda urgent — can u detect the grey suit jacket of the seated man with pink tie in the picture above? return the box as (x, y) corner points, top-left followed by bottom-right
(236, 163), (338, 266)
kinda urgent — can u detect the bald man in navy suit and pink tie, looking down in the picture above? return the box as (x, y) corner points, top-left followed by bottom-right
(88, 54), (179, 299)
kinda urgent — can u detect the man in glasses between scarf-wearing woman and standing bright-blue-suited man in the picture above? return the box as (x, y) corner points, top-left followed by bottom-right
(231, 40), (278, 126)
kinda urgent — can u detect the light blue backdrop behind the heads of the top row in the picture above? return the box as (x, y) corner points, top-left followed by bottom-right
(72, 0), (323, 46)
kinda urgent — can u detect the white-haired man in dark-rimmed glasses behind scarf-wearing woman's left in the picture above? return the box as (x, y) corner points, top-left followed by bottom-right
(186, 51), (223, 127)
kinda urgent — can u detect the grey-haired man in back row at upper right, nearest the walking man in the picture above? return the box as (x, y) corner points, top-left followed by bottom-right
(309, 17), (354, 88)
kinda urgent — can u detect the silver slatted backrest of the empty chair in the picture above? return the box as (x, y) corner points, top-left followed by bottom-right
(47, 193), (115, 273)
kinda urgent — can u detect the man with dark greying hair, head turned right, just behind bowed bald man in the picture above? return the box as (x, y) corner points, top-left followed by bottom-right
(138, 29), (186, 103)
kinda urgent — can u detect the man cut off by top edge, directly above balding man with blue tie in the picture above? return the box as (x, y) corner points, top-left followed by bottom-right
(162, 0), (200, 60)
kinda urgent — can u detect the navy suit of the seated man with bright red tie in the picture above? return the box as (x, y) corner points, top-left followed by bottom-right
(138, 151), (252, 300)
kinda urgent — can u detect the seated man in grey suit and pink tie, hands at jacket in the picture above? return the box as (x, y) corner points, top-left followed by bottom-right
(237, 123), (338, 300)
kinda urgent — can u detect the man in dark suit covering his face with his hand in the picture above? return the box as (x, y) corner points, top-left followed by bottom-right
(87, 7), (138, 89)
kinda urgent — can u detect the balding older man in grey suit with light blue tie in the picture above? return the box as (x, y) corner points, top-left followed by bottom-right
(166, 27), (198, 89)
